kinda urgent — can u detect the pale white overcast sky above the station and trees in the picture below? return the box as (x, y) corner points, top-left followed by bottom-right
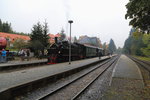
(0, 0), (131, 47)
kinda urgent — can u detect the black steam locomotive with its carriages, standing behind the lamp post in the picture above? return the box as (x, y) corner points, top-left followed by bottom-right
(48, 41), (105, 64)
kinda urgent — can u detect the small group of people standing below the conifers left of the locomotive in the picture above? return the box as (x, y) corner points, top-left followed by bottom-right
(19, 49), (30, 61)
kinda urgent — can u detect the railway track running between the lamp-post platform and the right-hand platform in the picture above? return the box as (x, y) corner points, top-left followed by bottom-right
(34, 57), (118, 100)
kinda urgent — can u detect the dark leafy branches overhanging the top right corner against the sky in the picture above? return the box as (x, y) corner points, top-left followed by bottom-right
(125, 0), (150, 33)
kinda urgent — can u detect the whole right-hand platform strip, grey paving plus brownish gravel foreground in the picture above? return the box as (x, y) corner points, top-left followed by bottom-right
(104, 55), (144, 100)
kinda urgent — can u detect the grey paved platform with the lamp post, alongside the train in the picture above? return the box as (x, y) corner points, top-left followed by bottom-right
(0, 57), (108, 92)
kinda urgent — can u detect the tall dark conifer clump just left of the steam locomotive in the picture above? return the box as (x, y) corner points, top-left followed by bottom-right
(30, 22), (49, 55)
